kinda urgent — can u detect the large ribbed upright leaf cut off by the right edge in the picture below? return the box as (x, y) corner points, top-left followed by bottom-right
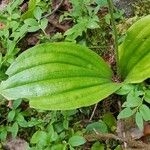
(119, 15), (150, 83)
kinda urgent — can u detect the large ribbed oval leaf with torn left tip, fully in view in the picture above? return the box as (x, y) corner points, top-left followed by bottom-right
(0, 43), (120, 110)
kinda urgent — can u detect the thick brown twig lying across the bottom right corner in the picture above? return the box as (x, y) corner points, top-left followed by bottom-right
(84, 132), (149, 150)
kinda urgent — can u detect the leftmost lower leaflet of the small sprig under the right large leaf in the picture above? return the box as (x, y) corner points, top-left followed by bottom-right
(118, 107), (133, 119)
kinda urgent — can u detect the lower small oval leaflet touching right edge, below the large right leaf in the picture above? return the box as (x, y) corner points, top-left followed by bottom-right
(139, 104), (150, 121)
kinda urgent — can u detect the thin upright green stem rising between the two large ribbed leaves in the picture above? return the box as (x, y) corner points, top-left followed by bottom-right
(107, 0), (119, 75)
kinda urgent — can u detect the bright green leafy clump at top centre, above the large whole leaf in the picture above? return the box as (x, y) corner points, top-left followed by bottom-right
(60, 0), (100, 41)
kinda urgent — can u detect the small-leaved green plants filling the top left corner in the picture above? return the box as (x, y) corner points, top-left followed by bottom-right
(0, 0), (48, 69)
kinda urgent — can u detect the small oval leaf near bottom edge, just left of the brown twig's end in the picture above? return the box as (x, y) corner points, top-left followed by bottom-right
(68, 135), (86, 147)
